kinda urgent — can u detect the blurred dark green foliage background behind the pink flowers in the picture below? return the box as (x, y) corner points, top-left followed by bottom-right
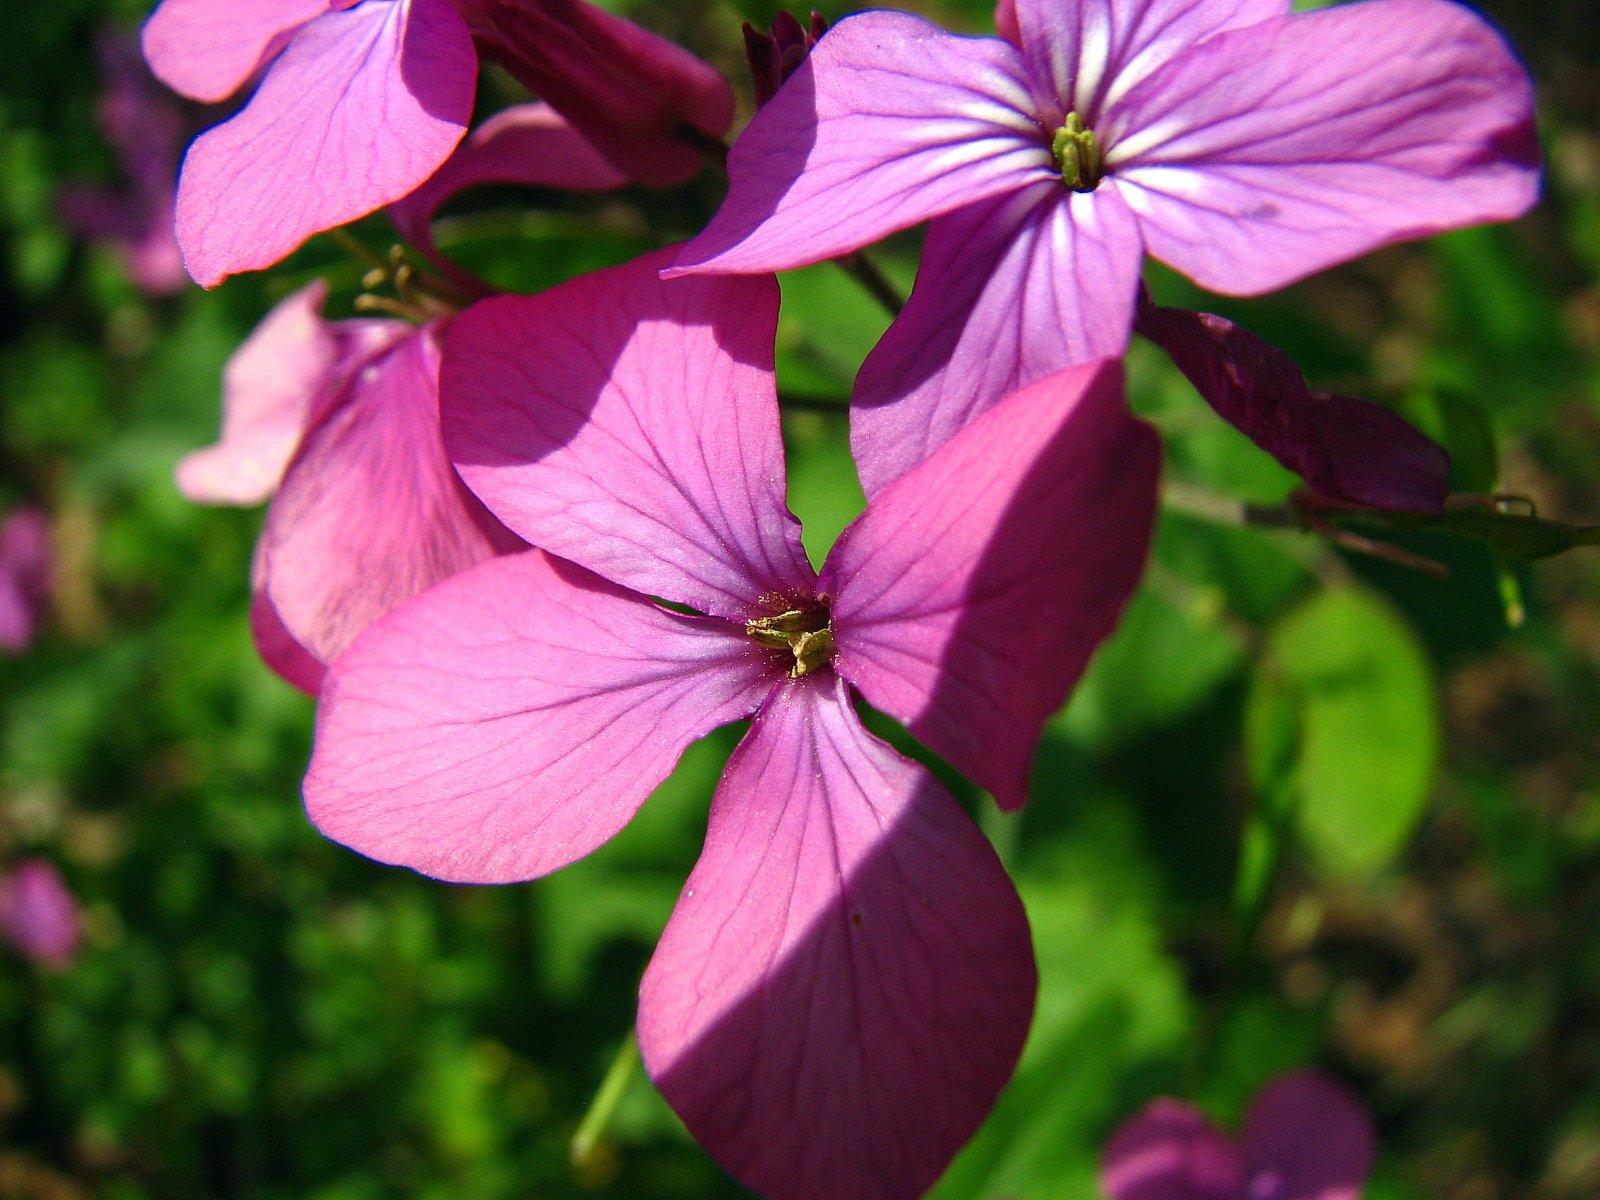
(0, 0), (1600, 1200)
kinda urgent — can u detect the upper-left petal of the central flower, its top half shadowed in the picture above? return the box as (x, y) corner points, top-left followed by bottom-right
(445, 251), (814, 616)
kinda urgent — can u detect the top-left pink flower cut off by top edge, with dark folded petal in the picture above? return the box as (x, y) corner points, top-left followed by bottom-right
(144, 0), (733, 286)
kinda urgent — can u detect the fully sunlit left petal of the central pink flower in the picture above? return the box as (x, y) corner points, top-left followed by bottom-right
(306, 550), (770, 883)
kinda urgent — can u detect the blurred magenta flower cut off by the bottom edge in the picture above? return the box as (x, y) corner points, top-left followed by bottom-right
(1101, 1070), (1374, 1200)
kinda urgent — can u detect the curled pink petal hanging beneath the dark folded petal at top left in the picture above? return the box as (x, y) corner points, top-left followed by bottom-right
(389, 104), (627, 286)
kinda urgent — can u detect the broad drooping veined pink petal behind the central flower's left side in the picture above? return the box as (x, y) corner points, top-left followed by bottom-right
(258, 326), (518, 662)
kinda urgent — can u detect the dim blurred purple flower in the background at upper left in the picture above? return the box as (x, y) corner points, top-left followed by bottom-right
(58, 35), (189, 296)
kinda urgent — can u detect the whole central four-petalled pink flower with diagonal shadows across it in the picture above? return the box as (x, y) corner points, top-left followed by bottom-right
(306, 251), (1158, 1200)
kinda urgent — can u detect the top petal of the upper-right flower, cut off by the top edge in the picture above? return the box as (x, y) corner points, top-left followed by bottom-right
(995, 0), (1290, 120)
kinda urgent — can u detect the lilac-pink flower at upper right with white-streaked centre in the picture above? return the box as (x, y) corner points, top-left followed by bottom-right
(680, 0), (1538, 496)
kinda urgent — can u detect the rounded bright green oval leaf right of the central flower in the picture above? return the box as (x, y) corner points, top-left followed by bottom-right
(1245, 589), (1438, 877)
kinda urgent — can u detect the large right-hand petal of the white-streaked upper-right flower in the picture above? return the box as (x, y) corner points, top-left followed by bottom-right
(1102, 0), (1539, 296)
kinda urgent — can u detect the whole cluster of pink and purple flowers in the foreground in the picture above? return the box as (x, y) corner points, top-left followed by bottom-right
(144, 0), (1538, 1200)
